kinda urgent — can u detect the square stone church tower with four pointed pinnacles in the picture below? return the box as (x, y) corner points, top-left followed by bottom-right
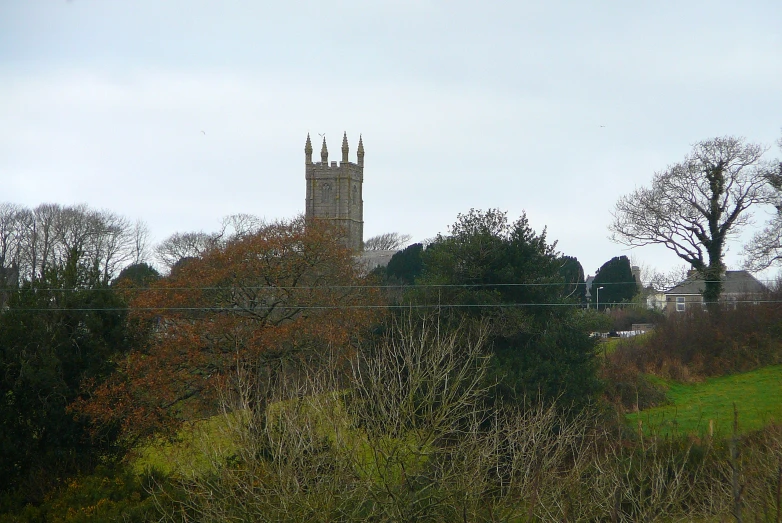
(304, 133), (364, 251)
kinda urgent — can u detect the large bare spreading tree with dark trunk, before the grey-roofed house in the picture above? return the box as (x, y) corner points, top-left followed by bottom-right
(609, 136), (771, 303)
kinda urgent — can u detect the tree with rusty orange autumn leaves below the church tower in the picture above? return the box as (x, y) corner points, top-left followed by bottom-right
(80, 217), (377, 437)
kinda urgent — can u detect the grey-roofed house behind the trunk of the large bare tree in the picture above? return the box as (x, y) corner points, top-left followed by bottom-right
(665, 271), (767, 314)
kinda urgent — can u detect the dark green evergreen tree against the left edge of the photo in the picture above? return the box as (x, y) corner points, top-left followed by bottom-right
(0, 249), (128, 500)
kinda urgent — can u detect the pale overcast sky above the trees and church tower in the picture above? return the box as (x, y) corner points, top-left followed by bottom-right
(0, 0), (782, 280)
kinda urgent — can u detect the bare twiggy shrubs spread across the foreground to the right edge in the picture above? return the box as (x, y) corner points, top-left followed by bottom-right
(152, 314), (782, 522)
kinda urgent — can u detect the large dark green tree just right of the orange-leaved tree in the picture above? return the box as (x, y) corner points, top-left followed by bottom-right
(412, 209), (599, 407)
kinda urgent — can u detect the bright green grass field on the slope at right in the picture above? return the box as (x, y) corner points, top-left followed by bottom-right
(627, 365), (782, 436)
